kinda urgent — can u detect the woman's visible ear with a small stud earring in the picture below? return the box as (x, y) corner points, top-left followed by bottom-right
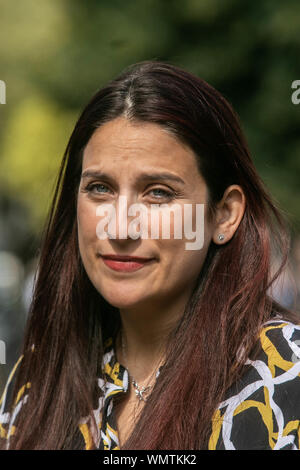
(212, 184), (246, 245)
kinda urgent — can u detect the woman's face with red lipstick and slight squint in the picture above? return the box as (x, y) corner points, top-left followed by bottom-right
(77, 117), (212, 309)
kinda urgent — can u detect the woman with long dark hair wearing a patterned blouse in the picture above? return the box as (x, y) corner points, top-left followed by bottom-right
(0, 61), (300, 449)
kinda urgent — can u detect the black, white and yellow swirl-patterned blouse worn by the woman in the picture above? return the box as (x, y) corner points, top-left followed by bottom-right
(0, 320), (300, 450)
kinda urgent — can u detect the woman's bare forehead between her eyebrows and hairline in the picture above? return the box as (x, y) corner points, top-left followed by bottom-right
(82, 117), (199, 180)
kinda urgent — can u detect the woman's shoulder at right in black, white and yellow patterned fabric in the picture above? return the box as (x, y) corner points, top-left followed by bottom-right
(210, 320), (300, 449)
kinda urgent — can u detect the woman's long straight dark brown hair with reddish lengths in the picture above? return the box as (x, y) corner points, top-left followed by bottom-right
(2, 61), (294, 449)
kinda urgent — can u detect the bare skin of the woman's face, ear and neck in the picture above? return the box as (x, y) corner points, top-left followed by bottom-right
(77, 117), (245, 384)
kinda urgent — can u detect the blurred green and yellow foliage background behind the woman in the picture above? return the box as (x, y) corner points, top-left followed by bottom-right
(0, 0), (300, 391)
